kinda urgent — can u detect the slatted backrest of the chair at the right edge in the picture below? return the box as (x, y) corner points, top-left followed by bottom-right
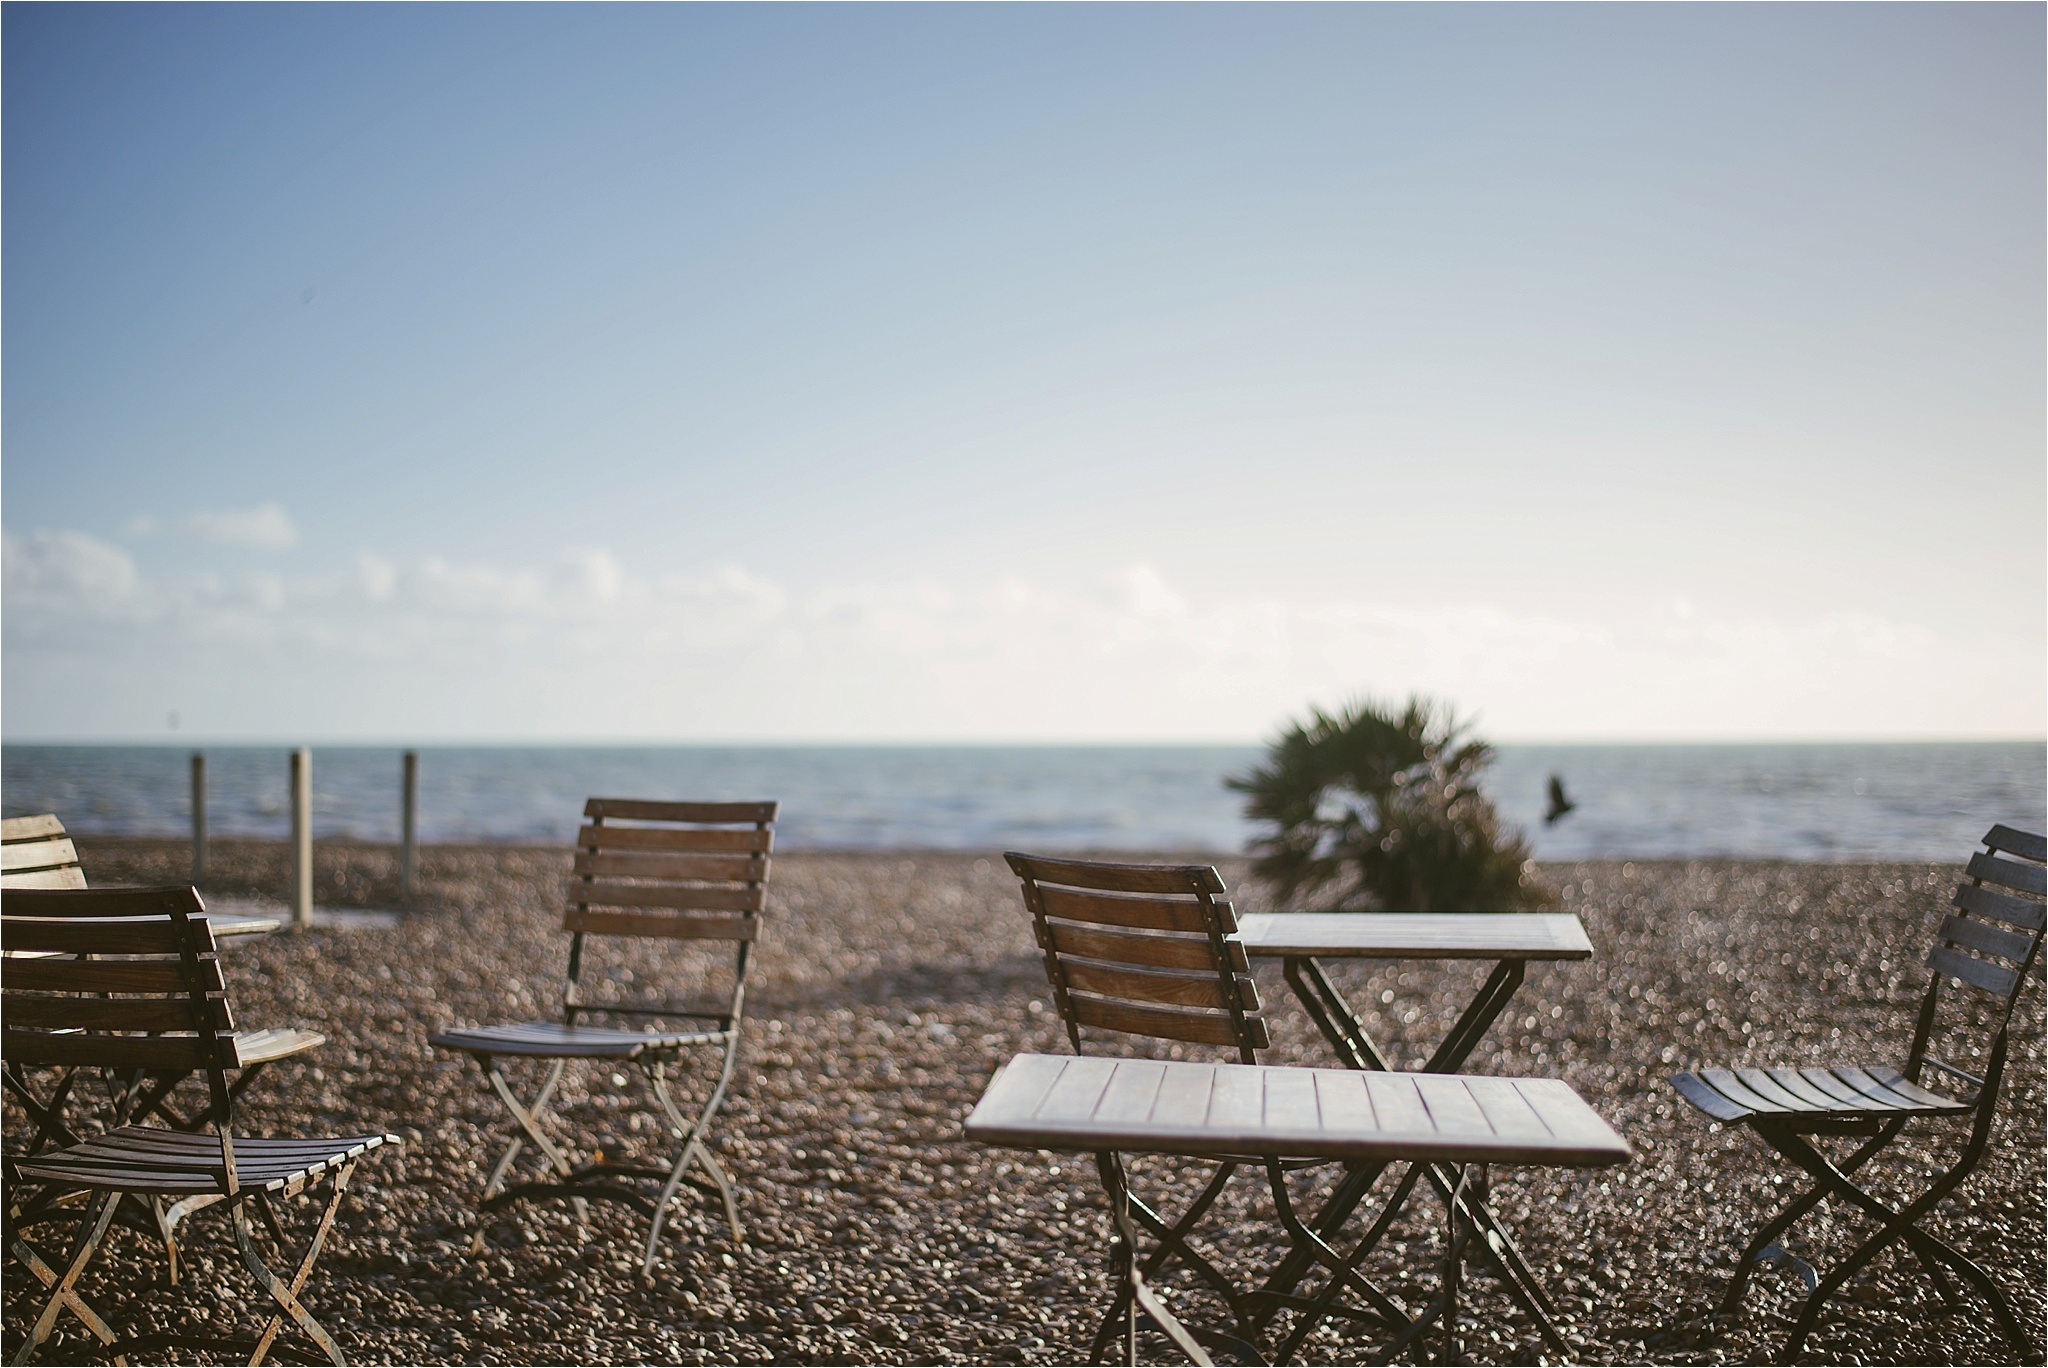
(1907, 825), (2048, 1094)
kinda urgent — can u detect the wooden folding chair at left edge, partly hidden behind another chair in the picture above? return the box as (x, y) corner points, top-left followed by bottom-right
(0, 813), (328, 1155)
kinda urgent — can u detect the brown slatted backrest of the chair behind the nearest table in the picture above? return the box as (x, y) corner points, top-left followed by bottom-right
(1004, 852), (1272, 1063)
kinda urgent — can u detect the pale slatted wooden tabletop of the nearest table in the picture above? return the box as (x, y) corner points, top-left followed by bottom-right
(967, 1055), (1630, 1167)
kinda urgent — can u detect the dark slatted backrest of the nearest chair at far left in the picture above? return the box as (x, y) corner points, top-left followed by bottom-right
(0, 887), (242, 1192)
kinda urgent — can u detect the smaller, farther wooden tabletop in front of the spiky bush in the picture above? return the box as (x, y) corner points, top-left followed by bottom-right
(1237, 911), (1593, 960)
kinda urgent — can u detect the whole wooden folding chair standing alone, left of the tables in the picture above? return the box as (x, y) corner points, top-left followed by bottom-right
(432, 799), (776, 1272)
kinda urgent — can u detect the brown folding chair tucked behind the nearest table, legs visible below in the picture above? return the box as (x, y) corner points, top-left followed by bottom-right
(1004, 852), (1413, 1362)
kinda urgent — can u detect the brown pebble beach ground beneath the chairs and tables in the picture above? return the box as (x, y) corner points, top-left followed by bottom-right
(6, 840), (2048, 1364)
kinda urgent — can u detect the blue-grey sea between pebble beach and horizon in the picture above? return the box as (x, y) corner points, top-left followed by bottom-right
(0, 741), (2048, 862)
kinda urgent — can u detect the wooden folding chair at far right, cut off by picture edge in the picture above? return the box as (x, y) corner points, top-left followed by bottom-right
(1671, 825), (2048, 1362)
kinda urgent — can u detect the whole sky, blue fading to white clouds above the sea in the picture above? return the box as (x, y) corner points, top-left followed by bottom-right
(0, 4), (2048, 741)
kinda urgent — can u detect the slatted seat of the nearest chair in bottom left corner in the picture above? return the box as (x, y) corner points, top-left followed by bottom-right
(16, 1126), (397, 1192)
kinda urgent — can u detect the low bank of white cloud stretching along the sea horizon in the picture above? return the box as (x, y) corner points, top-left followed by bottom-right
(4, 532), (2044, 739)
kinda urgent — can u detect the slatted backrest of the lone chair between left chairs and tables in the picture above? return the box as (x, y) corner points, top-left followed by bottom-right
(561, 799), (776, 1024)
